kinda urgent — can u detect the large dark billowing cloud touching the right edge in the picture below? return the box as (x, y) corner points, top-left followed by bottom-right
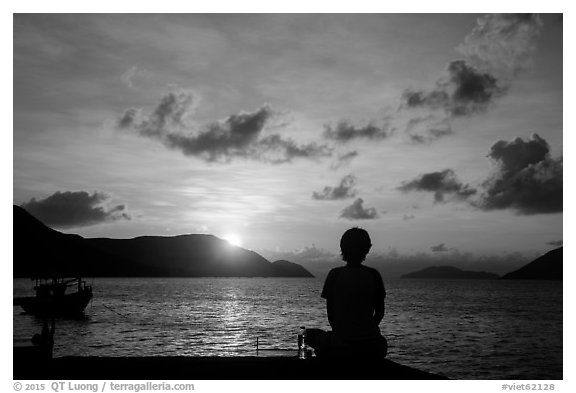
(478, 134), (563, 215)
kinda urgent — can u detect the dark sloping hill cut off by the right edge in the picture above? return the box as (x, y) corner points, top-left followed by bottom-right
(502, 247), (563, 280)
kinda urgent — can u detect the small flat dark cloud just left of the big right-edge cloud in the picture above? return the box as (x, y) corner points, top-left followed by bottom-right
(398, 169), (476, 203)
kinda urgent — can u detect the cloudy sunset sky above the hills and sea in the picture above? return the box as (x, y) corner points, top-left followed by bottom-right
(13, 14), (563, 270)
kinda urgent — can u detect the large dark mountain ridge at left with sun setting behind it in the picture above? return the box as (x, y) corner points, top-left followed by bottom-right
(13, 205), (313, 278)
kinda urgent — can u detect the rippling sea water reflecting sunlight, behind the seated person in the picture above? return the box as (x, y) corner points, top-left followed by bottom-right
(13, 278), (563, 379)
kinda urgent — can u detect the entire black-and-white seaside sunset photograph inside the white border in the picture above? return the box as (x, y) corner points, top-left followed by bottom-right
(11, 9), (570, 382)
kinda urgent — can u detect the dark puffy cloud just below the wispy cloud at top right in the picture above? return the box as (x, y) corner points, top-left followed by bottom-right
(403, 60), (506, 117)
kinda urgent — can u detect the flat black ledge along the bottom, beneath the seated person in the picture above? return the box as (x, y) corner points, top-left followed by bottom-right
(13, 356), (447, 380)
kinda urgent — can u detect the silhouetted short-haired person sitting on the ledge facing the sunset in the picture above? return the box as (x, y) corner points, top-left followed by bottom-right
(306, 228), (388, 358)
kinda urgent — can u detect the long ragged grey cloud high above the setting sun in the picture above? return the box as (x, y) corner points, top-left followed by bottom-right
(117, 91), (332, 164)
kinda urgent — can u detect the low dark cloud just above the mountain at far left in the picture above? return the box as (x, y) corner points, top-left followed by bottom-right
(21, 191), (130, 228)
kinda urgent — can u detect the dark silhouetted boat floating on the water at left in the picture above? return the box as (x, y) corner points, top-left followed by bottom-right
(14, 277), (92, 316)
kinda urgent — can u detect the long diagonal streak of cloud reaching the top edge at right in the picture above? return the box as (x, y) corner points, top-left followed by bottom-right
(401, 14), (542, 143)
